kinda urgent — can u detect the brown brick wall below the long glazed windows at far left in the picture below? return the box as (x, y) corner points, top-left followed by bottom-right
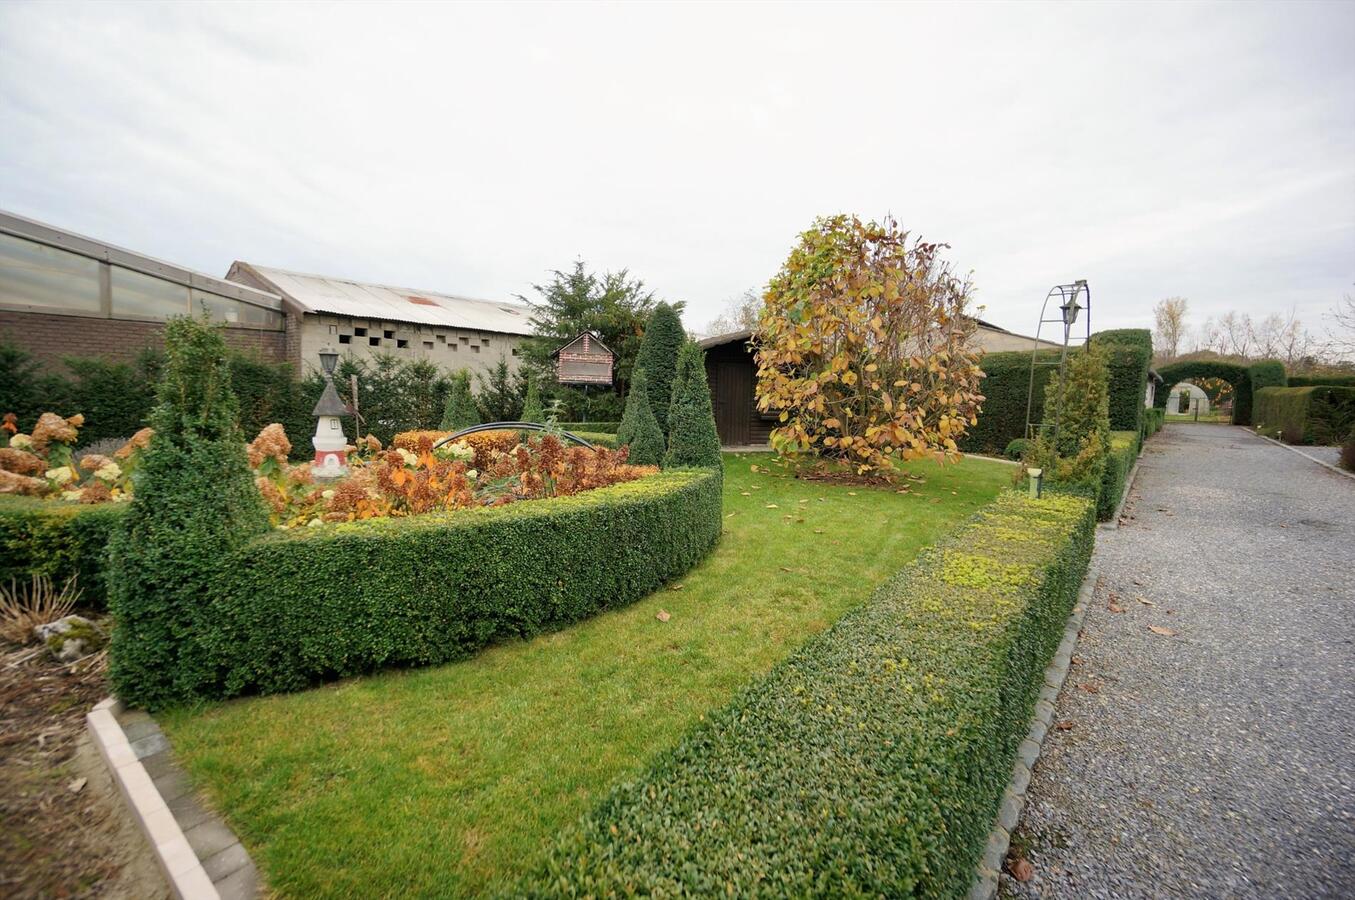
(0, 309), (289, 366)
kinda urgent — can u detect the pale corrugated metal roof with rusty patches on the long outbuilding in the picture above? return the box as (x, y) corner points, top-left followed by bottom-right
(232, 262), (531, 335)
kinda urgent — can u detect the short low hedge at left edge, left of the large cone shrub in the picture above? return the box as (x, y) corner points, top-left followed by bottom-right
(0, 496), (127, 610)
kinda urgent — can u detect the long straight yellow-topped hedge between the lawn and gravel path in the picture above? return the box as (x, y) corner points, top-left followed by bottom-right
(514, 491), (1095, 897)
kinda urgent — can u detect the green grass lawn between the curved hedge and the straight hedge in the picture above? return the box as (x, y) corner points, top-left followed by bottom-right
(164, 454), (1011, 897)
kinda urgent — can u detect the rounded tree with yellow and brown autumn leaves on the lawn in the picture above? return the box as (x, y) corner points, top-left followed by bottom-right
(755, 216), (982, 476)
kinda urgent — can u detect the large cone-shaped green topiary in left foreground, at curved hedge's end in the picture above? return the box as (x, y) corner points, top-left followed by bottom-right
(107, 317), (268, 709)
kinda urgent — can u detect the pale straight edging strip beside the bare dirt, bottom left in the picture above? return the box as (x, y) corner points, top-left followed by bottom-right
(85, 697), (221, 900)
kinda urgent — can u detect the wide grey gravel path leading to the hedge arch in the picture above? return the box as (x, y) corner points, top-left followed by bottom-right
(1003, 424), (1355, 897)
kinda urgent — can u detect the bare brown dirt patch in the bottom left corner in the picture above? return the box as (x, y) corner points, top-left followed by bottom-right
(0, 641), (169, 899)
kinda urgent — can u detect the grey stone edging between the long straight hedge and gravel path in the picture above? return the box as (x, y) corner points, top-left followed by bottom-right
(969, 558), (1100, 900)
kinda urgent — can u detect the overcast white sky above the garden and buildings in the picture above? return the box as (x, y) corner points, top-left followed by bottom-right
(0, 1), (1355, 337)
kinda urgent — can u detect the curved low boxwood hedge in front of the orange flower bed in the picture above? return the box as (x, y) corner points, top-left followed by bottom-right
(196, 469), (724, 697)
